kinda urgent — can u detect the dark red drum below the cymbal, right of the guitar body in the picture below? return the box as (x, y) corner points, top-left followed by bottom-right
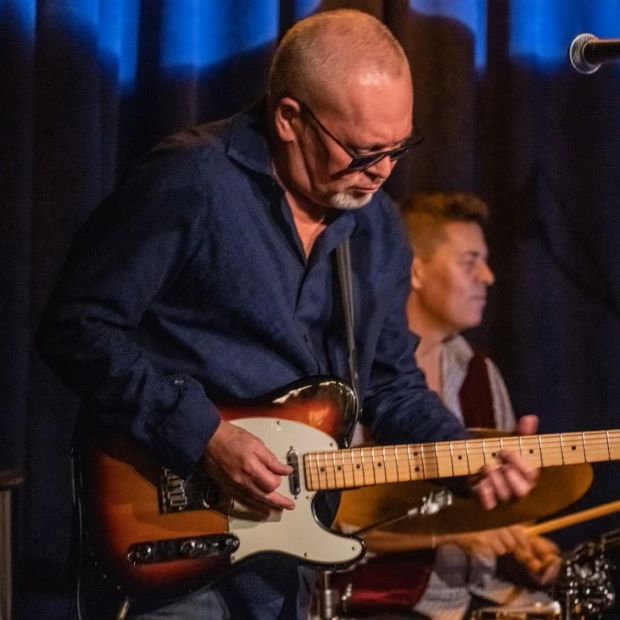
(331, 551), (433, 616)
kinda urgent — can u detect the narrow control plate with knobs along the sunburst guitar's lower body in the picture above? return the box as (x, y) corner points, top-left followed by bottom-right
(127, 534), (239, 565)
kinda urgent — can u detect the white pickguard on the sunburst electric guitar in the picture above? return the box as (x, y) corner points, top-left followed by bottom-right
(228, 417), (365, 566)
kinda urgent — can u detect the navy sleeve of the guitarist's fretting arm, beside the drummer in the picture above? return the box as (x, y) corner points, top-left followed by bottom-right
(362, 216), (468, 444)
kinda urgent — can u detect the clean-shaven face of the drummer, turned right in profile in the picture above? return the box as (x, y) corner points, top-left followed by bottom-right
(414, 222), (494, 334)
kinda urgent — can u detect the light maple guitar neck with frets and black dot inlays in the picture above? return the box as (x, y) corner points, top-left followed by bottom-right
(304, 430), (620, 491)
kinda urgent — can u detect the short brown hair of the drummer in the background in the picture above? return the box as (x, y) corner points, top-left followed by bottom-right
(400, 192), (489, 258)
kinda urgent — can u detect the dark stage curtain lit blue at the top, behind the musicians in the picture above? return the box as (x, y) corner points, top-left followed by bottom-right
(0, 0), (620, 612)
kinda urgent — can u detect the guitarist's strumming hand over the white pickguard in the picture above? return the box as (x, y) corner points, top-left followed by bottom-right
(202, 420), (295, 513)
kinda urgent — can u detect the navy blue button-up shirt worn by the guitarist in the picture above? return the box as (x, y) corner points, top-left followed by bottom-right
(38, 101), (463, 475)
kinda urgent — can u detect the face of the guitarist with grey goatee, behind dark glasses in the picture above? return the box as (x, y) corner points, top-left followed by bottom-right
(291, 71), (413, 209)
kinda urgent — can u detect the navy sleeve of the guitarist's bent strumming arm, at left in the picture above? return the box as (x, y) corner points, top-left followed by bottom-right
(37, 150), (220, 476)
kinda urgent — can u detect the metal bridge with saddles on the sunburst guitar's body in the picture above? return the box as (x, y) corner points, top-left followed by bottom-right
(158, 467), (220, 514)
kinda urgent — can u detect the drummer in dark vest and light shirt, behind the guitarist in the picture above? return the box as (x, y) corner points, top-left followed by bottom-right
(354, 193), (561, 620)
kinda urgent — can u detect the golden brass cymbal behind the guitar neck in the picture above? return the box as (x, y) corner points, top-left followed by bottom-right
(336, 429), (593, 534)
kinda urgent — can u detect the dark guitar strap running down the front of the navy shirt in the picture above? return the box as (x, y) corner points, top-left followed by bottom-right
(336, 238), (362, 447)
